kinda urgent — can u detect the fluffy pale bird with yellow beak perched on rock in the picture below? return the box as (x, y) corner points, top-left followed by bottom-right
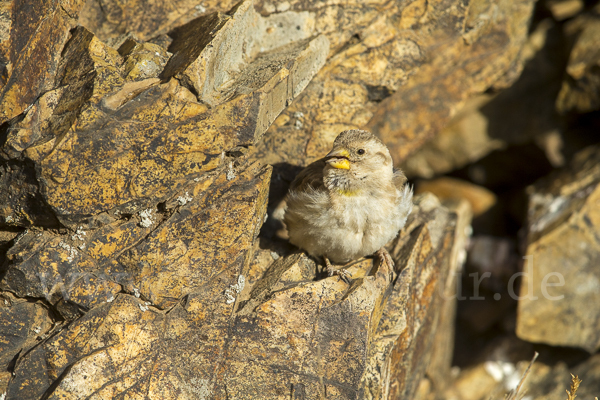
(283, 129), (413, 280)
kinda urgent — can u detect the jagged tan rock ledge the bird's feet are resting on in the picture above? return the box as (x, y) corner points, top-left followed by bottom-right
(7, 191), (468, 399)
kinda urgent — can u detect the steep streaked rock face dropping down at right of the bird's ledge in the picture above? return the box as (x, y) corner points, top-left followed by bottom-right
(363, 195), (470, 399)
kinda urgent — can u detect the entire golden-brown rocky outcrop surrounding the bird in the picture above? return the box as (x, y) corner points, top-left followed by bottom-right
(0, 0), (533, 399)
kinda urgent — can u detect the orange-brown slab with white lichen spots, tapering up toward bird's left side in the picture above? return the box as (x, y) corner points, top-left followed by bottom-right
(1, 161), (270, 310)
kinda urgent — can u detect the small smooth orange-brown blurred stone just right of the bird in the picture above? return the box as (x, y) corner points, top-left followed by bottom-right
(416, 177), (496, 217)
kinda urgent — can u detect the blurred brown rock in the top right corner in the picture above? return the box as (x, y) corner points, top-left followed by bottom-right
(556, 5), (600, 113)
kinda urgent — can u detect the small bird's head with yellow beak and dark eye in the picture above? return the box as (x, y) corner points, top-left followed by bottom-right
(324, 129), (393, 190)
